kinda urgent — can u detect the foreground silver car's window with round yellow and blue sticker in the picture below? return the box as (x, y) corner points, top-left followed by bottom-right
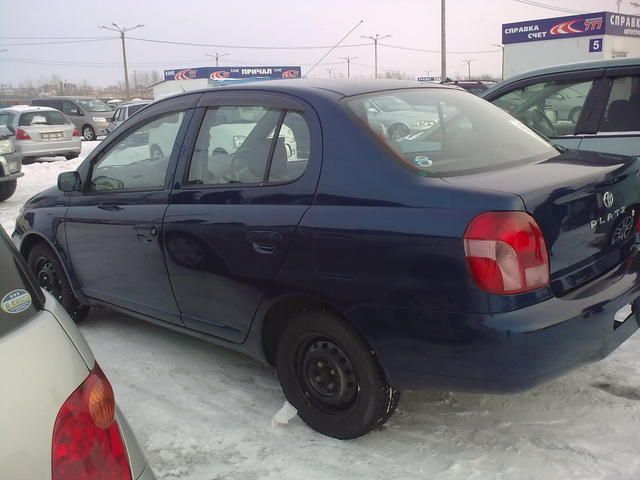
(0, 227), (44, 337)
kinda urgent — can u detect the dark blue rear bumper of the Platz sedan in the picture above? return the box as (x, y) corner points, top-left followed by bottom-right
(350, 248), (640, 393)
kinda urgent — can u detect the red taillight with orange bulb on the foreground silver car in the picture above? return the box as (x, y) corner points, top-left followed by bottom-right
(51, 363), (131, 480)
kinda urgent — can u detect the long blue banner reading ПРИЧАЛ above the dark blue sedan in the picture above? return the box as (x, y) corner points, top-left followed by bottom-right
(164, 66), (302, 81)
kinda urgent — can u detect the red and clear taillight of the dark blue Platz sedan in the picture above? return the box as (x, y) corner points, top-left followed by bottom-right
(464, 212), (549, 295)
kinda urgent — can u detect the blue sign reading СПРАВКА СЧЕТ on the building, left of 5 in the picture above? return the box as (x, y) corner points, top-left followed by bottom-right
(502, 12), (607, 44)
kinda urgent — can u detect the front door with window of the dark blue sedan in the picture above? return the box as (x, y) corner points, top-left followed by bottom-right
(65, 110), (190, 324)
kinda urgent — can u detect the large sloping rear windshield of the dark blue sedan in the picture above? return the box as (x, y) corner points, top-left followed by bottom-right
(345, 88), (558, 177)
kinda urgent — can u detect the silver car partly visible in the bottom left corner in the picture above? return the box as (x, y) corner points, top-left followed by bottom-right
(0, 227), (155, 480)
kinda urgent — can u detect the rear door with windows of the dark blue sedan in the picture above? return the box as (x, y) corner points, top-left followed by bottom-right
(164, 91), (322, 342)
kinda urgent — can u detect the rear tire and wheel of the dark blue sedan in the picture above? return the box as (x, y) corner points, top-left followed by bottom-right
(276, 311), (400, 440)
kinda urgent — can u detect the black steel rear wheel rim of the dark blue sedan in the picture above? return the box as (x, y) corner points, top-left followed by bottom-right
(296, 336), (359, 415)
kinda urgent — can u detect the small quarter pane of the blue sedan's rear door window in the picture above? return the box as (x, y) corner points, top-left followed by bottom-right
(268, 111), (311, 182)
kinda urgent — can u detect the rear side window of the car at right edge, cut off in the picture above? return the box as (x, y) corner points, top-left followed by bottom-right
(599, 75), (640, 132)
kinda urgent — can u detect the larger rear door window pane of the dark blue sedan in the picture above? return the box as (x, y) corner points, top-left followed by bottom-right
(187, 106), (282, 185)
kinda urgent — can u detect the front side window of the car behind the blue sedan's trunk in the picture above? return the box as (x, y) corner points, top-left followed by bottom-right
(492, 80), (593, 138)
